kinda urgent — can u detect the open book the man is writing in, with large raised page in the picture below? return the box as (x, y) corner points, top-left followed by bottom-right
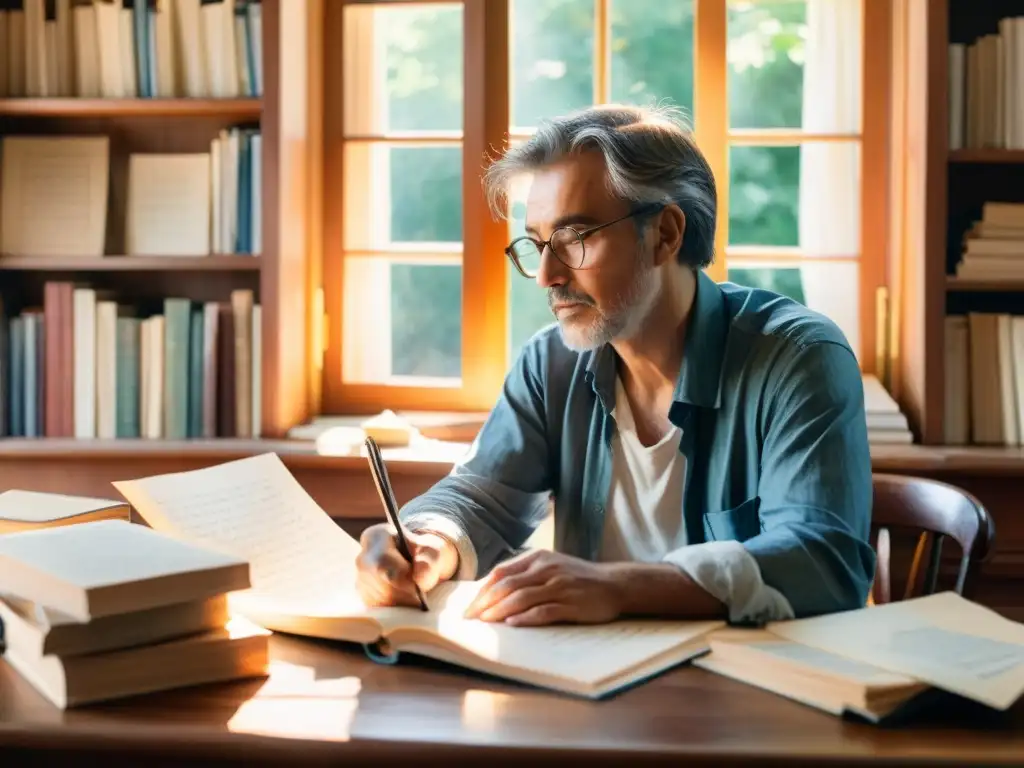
(114, 454), (723, 698)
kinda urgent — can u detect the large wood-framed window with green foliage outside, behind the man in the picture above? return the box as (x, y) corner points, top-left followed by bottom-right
(324, 0), (888, 413)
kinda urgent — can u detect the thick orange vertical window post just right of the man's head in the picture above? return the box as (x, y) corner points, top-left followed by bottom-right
(693, 0), (729, 281)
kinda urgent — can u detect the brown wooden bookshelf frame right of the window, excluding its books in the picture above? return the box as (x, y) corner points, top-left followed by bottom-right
(888, 0), (1024, 612)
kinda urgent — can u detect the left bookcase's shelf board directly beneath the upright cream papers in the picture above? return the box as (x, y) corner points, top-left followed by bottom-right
(0, 254), (261, 272)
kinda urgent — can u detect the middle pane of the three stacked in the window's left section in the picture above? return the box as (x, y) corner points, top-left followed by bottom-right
(344, 143), (462, 251)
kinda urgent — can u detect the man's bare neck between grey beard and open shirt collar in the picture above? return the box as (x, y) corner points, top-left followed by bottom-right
(612, 268), (696, 399)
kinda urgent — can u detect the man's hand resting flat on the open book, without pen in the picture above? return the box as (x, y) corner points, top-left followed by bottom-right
(466, 550), (624, 627)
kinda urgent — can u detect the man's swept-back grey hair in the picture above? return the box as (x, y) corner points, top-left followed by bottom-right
(483, 104), (717, 268)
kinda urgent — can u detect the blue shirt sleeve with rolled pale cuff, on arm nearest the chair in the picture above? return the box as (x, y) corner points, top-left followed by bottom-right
(666, 342), (874, 623)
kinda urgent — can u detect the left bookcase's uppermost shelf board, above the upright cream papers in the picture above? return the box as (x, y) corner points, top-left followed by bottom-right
(0, 96), (263, 121)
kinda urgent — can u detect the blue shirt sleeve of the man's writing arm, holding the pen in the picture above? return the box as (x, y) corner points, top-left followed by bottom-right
(400, 343), (552, 580)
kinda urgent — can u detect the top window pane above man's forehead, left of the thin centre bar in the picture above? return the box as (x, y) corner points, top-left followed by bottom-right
(511, 0), (594, 128)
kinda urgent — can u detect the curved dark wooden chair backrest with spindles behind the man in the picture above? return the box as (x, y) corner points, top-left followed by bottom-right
(871, 473), (995, 603)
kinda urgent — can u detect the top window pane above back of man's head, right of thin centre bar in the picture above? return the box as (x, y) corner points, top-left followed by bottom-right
(609, 0), (693, 115)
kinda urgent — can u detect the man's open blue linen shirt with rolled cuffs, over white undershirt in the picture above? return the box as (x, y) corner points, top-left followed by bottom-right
(401, 272), (874, 623)
